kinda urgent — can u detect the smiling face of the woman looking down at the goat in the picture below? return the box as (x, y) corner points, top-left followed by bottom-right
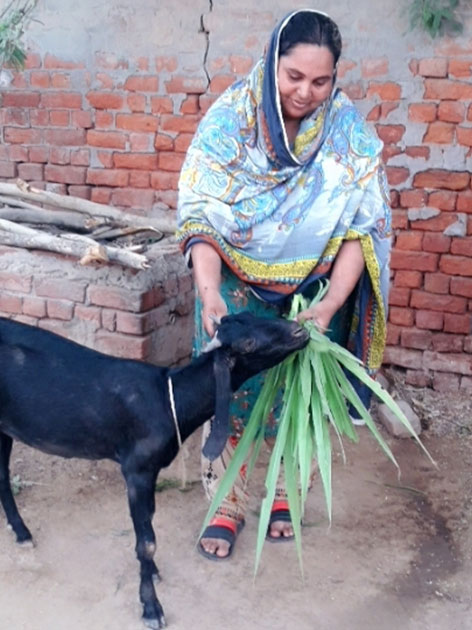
(277, 44), (334, 121)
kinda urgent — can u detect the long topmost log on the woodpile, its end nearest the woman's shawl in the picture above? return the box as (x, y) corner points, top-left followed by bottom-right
(0, 180), (176, 234)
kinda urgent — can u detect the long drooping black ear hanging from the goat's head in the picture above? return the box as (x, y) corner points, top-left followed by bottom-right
(203, 352), (232, 461)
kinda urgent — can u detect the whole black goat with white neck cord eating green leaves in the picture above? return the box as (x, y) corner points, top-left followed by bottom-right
(0, 313), (308, 628)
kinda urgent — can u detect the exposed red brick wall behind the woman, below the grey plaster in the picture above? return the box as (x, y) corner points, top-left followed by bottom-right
(0, 25), (472, 391)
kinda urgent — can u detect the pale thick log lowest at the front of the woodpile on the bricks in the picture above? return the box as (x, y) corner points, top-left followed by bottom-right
(0, 219), (151, 269)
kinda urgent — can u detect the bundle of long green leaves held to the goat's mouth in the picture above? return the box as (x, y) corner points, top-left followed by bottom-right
(202, 285), (434, 573)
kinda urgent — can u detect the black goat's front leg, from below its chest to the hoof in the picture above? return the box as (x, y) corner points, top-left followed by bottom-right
(123, 467), (166, 629)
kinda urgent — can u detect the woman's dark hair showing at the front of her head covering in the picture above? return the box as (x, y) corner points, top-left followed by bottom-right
(279, 11), (342, 65)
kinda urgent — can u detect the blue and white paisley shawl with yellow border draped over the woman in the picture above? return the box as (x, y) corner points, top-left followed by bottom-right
(177, 9), (391, 369)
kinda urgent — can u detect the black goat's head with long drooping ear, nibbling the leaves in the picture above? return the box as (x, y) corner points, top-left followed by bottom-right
(203, 312), (309, 460)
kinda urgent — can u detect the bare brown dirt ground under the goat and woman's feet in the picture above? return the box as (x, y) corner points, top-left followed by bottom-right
(0, 376), (472, 630)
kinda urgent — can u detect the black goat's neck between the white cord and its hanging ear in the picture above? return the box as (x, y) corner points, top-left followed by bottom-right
(169, 352), (221, 440)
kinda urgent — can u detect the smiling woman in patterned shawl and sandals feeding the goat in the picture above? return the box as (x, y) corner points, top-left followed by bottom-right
(178, 9), (390, 559)
